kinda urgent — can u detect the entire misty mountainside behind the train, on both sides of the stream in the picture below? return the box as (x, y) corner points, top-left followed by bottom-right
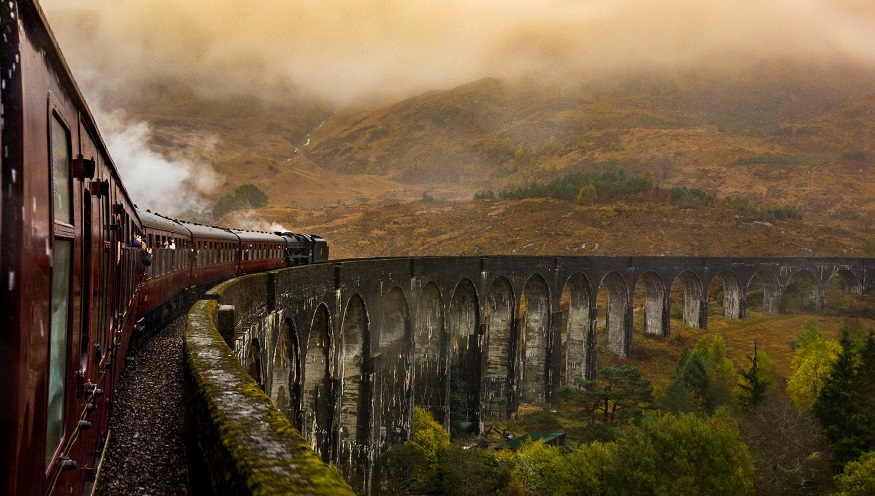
(116, 66), (875, 233)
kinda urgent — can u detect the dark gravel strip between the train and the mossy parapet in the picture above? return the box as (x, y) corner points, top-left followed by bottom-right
(95, 316), (191, 496)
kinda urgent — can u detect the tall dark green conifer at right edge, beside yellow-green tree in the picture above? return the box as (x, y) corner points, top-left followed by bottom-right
(813, 327), (875, 468)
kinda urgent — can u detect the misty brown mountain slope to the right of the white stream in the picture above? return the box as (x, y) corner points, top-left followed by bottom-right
(296, 69), (875, 221)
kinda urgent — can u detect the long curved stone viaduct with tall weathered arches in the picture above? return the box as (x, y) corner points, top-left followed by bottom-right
(207, 257), (875, 487)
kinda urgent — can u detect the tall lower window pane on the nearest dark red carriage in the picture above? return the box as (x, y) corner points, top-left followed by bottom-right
(45, 239), (73, 465)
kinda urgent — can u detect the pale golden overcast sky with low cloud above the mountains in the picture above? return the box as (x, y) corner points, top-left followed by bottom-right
(41, 0), (875, 105)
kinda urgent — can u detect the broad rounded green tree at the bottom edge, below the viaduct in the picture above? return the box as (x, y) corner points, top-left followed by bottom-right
(607, 412), (753, 496)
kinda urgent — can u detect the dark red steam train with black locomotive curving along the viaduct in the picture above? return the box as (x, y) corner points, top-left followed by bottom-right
(0, 0), (328, 494)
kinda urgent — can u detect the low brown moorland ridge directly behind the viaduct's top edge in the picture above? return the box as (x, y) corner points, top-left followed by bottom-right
(229, 200), (875, 258)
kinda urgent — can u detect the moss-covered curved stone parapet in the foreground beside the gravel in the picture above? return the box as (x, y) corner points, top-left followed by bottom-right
(184, 300), (353, 495)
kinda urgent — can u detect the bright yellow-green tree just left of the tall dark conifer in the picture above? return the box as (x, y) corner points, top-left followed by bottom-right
(787, 319), (842, 408)
